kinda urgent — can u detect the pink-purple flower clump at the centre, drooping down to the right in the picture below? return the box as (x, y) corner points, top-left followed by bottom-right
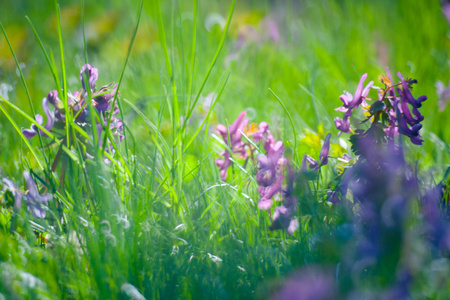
(216, 111), (298, 233)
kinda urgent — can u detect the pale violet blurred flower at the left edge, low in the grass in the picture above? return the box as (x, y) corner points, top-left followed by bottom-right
(2, 171), (53, 219)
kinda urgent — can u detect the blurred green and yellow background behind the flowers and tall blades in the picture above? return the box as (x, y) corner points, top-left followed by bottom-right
(0, 0), (450, 173)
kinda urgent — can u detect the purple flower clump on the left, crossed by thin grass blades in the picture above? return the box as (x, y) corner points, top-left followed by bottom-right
(22, 64), (123, 161)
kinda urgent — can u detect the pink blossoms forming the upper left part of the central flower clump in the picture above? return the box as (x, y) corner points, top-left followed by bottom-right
(216, 111), (248, 180)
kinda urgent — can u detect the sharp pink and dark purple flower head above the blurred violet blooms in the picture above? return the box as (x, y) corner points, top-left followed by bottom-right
(334, 68), (427, 145)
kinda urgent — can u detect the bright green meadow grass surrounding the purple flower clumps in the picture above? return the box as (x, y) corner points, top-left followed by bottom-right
(0, 0), (450, 299)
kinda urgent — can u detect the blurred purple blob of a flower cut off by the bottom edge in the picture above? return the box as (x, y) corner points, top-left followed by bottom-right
(270, 267), (339, 300)
